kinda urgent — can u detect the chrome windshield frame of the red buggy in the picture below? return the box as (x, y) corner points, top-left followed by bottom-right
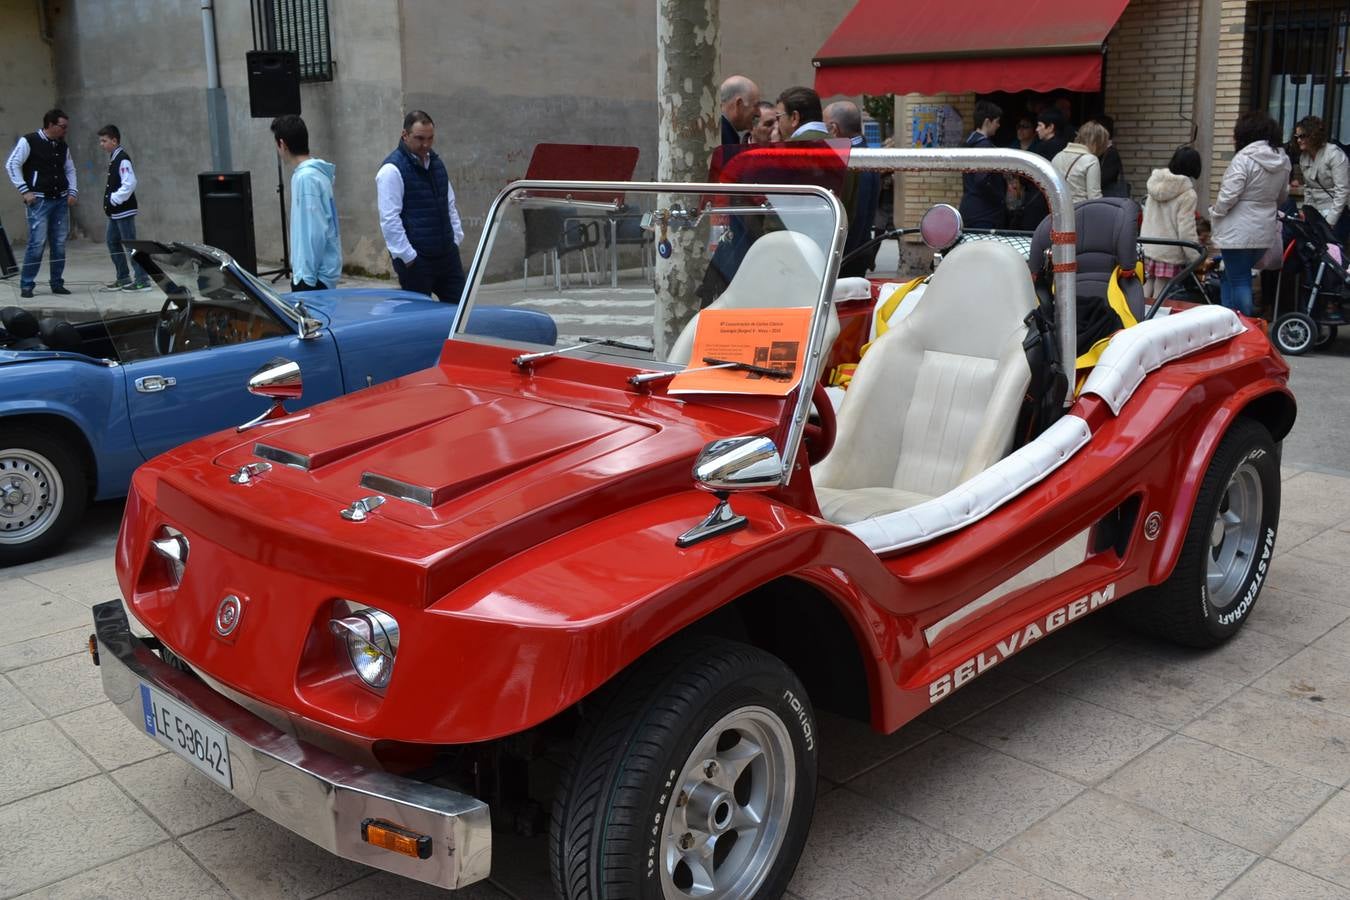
(464, 179), (848, 484)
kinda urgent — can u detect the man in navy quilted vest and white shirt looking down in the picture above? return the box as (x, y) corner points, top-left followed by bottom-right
(375, 109), (464, 304)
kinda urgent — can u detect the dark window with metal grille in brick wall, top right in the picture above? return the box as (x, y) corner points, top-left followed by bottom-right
(1246, 0), (1350, 143)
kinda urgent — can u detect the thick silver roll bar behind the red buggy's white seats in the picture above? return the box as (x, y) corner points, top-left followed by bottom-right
(848, 147), (1079, 399)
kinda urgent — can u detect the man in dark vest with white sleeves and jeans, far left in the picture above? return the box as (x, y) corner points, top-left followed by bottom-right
(5, 109), (78, 298)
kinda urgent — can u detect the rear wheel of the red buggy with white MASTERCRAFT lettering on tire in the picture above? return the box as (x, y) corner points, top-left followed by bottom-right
(1121, 418), (1280, 648)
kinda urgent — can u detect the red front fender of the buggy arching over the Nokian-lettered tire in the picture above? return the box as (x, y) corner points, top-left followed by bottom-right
(405, 491), (907, 743)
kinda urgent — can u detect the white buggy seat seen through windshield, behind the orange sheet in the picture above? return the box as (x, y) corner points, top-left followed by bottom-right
(667, 231), (840, 366)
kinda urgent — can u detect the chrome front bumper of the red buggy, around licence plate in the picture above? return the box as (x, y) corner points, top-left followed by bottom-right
(93, 600), (493, 888)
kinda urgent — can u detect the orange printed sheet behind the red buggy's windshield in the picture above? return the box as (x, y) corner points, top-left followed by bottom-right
(667, 306), (811, 397)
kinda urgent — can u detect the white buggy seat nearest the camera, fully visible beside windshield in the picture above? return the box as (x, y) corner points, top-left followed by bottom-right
(811, 242), (1035, 525)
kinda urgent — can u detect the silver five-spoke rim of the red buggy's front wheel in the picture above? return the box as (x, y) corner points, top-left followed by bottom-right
(660, 707), (797, 899)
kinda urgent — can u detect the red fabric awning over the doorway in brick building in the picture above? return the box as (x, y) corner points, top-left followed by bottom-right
(814, 0), (1129, 97)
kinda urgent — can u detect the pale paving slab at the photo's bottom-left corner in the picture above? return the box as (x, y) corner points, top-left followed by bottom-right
(0, 776), (165, 897)
